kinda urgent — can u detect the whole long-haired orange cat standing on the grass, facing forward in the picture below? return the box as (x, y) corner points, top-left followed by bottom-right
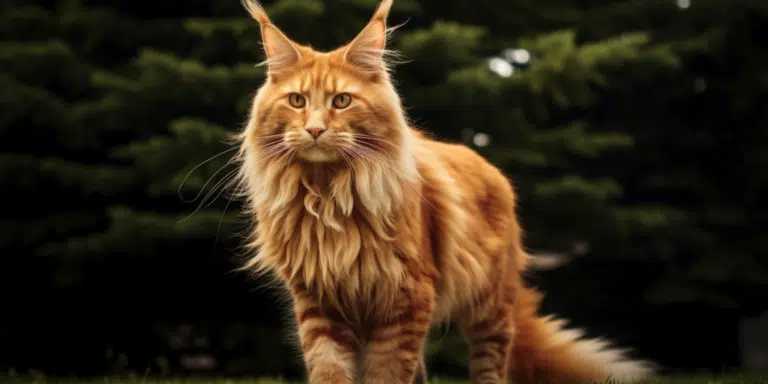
(234, 0), (652, 384)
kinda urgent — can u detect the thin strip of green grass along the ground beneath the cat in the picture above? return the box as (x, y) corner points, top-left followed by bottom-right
(0, 375), (768, 384)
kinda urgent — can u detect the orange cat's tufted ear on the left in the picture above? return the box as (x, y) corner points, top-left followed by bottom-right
(241, 0), (301, 74)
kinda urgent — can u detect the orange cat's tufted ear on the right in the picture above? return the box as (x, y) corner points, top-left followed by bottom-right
(344, 0), (392, 72)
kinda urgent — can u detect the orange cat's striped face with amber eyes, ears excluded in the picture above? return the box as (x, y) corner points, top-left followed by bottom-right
(253, 50), (399, 162)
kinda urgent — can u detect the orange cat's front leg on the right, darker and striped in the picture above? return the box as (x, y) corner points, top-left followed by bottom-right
(363, 287), (434, 384)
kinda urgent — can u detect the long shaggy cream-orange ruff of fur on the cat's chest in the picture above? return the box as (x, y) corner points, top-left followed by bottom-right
(250, 166), (405, 311)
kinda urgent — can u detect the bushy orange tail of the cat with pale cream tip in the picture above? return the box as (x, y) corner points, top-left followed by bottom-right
(510, 288), (656, 384)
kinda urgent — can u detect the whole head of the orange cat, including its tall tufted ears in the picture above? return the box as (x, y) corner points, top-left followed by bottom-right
(243, 0), (410, 166)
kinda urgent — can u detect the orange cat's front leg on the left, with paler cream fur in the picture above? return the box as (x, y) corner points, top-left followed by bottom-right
(294, 294), (359, 384)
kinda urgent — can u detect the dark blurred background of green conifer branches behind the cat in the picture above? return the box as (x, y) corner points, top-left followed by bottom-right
(0, 0), (768, 378)
